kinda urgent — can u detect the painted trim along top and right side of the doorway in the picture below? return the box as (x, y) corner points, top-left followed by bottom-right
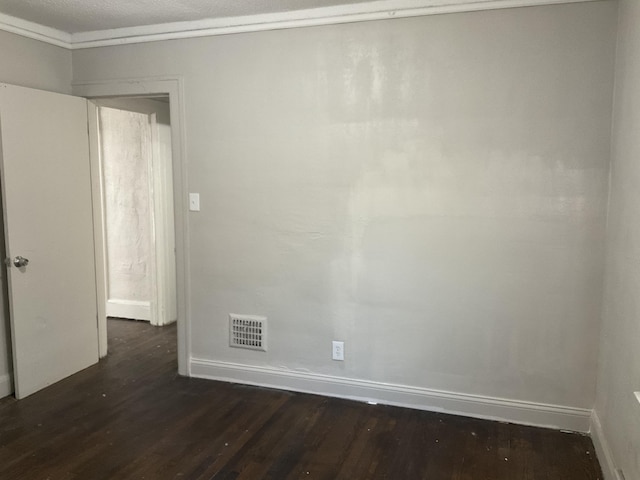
(72, 76), (191, 376)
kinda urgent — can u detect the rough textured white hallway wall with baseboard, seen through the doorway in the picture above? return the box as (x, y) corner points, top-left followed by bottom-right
(98, 107), (153, 321)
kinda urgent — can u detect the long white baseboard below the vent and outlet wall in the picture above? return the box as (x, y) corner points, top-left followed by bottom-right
(190, 358), (591, 433)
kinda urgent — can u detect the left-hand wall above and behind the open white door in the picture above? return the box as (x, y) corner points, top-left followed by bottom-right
(0, 31), (71, 397)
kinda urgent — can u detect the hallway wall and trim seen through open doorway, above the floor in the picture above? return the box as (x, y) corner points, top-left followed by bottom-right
(93, 96), (177, 353)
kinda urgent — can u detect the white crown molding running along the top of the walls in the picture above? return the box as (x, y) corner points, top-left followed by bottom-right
(0, 0), (602, 49)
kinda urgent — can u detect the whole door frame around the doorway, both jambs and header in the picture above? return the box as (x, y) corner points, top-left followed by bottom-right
(72, 76), (191, 376)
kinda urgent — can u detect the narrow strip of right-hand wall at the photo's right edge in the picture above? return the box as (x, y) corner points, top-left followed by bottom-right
(595, 0), (640, 480)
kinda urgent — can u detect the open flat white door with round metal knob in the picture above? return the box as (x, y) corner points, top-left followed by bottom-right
(0, 84), (98, 398)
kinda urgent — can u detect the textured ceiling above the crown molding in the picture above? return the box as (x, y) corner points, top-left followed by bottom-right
(0, 0), (380, 33)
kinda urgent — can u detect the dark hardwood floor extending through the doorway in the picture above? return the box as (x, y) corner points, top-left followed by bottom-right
(0, 320), (603, 480)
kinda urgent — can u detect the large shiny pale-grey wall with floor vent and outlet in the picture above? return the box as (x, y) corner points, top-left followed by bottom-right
(73, 2), (616, 424)
